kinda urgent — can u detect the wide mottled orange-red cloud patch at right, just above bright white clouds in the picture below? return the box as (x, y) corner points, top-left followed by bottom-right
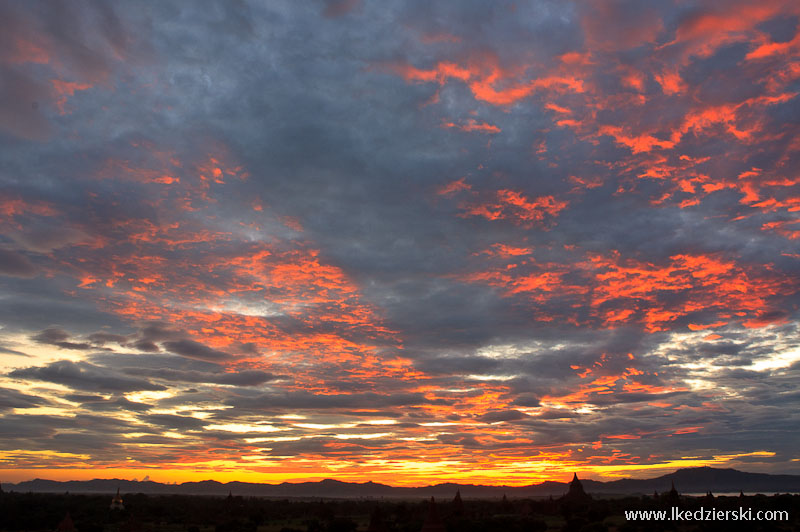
(459, 246), (798, 332)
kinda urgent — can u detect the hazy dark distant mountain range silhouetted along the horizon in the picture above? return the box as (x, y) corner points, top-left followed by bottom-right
(2, 467), (800, 499)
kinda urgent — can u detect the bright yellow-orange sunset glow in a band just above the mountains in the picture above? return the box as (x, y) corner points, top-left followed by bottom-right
(0, 448), (775, 487)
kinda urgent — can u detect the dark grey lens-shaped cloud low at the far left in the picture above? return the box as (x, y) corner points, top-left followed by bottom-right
(8, 360), (167, 392)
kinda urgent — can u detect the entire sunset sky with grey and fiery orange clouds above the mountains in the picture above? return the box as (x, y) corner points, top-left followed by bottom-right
(0, 0), (800, 486)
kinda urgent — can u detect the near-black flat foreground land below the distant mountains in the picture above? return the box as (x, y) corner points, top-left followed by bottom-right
(0, 492), (800, 532)
